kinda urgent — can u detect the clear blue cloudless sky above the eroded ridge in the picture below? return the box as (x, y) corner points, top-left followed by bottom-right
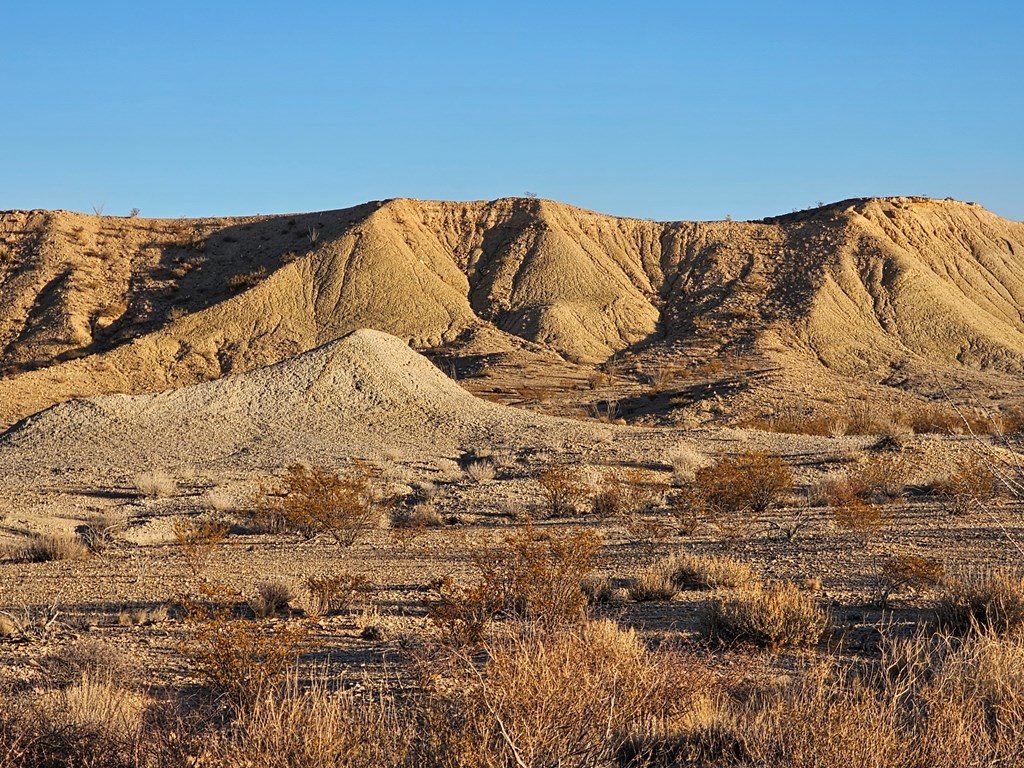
(0, 0), (1024, 220)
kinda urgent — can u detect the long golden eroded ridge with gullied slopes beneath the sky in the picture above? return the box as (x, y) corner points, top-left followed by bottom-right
(0, 198), (1024, 424)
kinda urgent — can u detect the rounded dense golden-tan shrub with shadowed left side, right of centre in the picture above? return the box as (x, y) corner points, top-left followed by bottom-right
(708, 582), (828, 649)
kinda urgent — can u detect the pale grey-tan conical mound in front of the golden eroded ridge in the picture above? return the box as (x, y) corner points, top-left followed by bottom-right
(0, 330), (608, 476)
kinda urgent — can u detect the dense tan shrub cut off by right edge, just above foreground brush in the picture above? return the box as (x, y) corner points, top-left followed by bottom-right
(936, 570), (1024, 635)
